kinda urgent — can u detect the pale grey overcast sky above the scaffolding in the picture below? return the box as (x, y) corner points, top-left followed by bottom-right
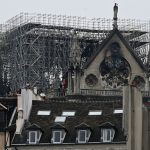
(0, 0), (150, 23)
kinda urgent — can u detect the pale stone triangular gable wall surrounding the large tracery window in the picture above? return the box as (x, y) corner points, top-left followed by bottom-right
(80, 34), (146, 90)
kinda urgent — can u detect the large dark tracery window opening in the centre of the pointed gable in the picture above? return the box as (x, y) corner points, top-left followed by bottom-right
(99, 42), (131, 89)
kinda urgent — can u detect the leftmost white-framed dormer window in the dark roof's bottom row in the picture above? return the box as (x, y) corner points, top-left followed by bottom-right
(29, 131), (41, 144)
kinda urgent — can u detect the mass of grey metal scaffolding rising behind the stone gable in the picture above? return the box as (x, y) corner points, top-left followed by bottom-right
(0, 13), (150, 92)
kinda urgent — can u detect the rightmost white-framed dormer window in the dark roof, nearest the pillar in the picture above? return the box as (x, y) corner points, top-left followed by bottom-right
(101, 129), (115, 142)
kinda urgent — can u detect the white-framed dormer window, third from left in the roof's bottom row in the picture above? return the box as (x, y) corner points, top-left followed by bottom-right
(77, 130), (91, 143)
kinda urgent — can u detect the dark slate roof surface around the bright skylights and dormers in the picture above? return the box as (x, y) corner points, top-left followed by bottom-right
(13, 96), (126, 144)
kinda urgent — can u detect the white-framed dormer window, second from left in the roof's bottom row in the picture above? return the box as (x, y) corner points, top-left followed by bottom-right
(52, 130), (65, 144)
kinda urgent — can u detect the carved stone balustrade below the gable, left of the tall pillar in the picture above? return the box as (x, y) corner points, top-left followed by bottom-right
(81, 89), (122, 96)
